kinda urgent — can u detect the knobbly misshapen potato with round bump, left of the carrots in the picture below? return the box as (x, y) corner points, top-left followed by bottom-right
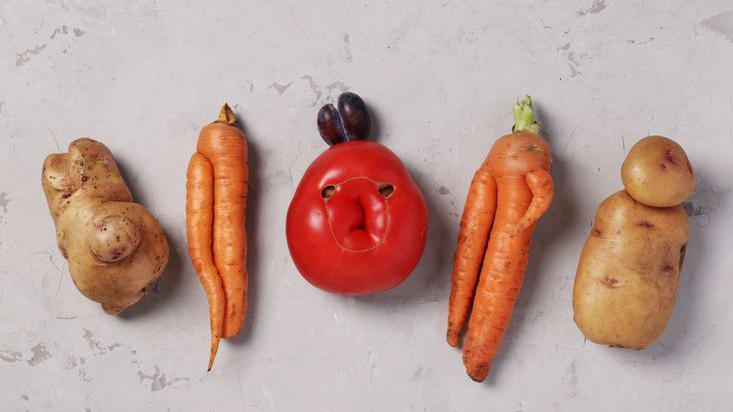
(42, 139), (168, 314)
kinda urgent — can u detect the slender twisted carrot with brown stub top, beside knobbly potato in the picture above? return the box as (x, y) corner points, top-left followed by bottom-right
(186, 104), (249, 370)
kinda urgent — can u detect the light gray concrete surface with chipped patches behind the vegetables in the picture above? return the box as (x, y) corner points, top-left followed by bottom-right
(0, 0), (733, 411)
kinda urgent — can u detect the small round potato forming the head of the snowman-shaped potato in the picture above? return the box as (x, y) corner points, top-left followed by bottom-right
(621, 136), (695, 207)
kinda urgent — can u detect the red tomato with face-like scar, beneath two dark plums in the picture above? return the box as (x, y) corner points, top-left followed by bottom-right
(286, 140), (428, 295)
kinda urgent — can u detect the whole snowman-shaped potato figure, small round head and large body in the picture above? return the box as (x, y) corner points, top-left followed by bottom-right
(573, 136), (695, 349)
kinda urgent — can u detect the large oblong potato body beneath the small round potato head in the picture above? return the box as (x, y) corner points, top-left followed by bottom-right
(573, 191), (689, 349)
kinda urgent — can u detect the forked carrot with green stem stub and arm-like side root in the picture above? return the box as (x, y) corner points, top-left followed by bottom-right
(447, 96), (553, 382)
